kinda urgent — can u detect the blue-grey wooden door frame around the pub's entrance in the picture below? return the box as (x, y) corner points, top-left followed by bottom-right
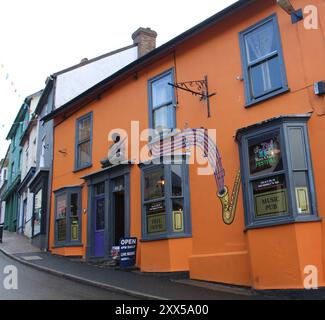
(84, 164), (131, 260)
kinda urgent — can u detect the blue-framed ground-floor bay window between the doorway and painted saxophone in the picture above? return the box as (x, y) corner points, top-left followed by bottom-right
(142, 162), (191, 241)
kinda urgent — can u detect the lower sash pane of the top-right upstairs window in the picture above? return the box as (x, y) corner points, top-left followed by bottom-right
(250, 57), (282, 98)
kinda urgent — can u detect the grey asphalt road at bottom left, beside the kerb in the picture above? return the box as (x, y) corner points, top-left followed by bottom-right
(0, 253), (135, 300)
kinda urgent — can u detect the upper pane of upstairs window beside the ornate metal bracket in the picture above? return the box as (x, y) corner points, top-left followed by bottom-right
(152, 74), (173, 109)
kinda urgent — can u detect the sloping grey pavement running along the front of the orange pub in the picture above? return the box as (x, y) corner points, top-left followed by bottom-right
(0, 231), (318, 300)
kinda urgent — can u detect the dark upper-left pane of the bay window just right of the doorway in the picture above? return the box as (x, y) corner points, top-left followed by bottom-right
(144, 167), (165, 201)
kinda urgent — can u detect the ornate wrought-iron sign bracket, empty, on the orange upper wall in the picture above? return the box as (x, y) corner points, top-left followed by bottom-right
(168, 76), (216, 118)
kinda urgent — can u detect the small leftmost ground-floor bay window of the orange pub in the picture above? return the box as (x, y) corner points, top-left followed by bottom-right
(55, 187), (81, 246)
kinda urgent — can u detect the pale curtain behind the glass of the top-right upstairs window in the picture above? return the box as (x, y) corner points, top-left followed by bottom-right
(246, 24), (276, 91)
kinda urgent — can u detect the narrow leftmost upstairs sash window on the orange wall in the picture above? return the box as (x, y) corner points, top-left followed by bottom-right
(75, 113), (92, 170)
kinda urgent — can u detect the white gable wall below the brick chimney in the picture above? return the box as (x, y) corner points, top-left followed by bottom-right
(54, 47), (138, 109)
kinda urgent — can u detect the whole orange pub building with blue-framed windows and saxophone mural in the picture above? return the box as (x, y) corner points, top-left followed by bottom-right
(44, 0), (325, 289)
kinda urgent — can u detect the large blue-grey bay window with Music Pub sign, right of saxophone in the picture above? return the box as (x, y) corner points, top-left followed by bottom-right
(237, 116), (318, 228)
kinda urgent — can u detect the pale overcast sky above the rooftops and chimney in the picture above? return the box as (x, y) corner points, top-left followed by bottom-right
(0, 0), (235, 158)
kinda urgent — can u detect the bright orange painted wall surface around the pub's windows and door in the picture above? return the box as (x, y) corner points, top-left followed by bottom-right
(51, 0), (325, 289)
